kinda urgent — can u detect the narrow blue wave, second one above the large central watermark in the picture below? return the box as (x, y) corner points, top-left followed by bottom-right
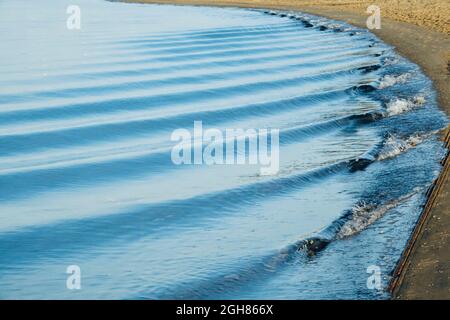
(0, 46), (378, 121)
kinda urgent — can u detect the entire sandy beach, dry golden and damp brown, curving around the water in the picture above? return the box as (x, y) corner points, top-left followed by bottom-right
(127, 0), (450, 299)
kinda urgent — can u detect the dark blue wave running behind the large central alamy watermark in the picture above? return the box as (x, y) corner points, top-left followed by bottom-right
(0, 116), (354, 200)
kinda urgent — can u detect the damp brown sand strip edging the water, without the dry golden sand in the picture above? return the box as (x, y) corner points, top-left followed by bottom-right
(122, 0), (450, 299)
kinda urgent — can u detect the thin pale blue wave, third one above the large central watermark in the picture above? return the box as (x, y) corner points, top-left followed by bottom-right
(0, 45), (380, 100)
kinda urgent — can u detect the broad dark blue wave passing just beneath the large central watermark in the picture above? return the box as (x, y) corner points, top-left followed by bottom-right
(0, 161), (347, 266)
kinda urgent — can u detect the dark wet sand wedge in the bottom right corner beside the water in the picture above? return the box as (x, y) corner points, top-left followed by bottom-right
(390, 130), (450, 299)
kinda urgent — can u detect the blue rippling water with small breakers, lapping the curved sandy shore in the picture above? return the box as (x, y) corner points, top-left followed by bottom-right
(0, 0), (447, 299)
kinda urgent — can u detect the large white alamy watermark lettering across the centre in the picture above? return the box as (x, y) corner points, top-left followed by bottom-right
(171, 121), (280, 175)
